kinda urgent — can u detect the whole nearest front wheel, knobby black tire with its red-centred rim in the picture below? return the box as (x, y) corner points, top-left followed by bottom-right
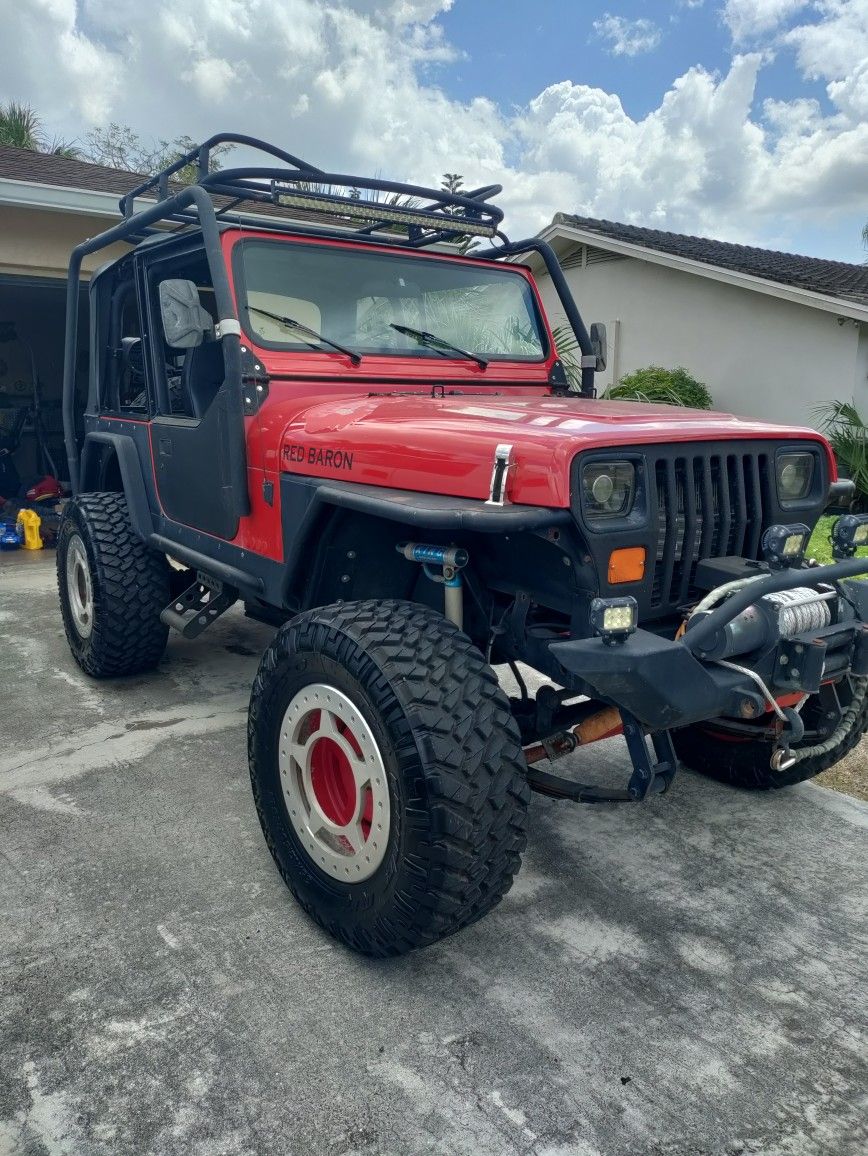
(247, 599), (531, 956)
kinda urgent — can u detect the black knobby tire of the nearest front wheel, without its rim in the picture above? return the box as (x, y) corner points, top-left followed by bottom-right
(247, 601), (531, 956)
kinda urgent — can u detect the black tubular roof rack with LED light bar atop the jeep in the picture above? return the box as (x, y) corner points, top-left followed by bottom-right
(120, 133), (506, 247)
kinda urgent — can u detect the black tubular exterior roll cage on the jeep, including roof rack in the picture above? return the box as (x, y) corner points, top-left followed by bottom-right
(62, 133), (595, 499)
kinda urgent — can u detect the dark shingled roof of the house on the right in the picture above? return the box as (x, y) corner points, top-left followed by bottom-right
(552, 213), (868, 305)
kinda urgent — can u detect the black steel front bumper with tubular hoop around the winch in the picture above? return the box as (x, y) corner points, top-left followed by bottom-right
(549, 558), (868, 731)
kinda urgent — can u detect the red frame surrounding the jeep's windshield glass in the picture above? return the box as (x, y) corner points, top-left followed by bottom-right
(231, 231), (554, 362)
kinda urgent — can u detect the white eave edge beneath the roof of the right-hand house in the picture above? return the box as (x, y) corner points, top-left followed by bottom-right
(539, 223), (868, 323)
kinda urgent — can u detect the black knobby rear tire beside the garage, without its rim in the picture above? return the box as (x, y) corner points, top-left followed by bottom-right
(57, 494), (171, 679)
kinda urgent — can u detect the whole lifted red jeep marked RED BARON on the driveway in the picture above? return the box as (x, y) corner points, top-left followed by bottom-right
(57, 135), (868, 955)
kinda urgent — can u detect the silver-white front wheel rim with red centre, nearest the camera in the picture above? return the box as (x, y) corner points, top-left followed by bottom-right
(277, 682), (391, 883)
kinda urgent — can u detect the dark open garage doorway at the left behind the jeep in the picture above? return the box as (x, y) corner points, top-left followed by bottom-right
(0, 275), (88, 505)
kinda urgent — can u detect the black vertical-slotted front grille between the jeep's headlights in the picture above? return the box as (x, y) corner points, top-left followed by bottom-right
(648, 452), (769, 609)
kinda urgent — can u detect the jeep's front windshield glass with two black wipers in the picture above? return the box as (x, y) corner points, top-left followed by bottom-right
(235, 240), (546, 361)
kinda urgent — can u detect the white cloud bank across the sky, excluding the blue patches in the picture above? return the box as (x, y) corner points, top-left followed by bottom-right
(0, 0), (868, 252)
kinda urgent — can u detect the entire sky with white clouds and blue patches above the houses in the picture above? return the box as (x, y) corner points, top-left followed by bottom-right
(0, 0), (868, 261)
